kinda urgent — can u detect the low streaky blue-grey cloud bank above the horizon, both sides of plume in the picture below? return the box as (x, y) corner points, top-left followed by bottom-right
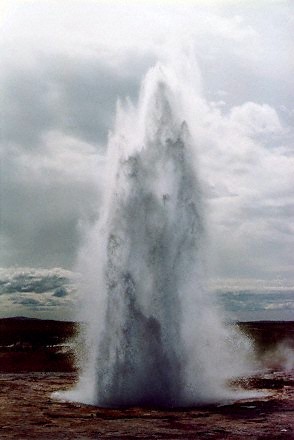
(0, 267), (294, 321)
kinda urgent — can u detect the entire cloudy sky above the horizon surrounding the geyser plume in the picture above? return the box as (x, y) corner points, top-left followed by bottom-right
(0, 0), (294, 319)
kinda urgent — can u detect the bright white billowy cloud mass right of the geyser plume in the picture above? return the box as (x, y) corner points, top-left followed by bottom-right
(191, 96), (294, 279)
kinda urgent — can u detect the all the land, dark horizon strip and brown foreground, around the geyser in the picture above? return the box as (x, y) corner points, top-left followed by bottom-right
(0, 319), (294, 440)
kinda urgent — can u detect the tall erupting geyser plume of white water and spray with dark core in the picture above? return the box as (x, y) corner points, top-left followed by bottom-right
(68, 61), (253, 406)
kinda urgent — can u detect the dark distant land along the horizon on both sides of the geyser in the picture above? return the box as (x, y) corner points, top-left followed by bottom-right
(0, 316), (294, 373)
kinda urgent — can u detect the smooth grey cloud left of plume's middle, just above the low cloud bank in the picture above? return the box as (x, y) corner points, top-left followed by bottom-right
(1, 167), (98, 266)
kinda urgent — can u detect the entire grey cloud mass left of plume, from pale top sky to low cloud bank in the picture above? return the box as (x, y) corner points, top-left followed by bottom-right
(0, 49), (150, 267)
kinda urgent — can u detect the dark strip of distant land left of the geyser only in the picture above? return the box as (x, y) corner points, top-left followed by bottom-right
(0, 318), (79, 372)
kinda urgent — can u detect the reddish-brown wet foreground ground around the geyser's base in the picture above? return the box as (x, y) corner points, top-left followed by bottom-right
(0, 371), (294, 440)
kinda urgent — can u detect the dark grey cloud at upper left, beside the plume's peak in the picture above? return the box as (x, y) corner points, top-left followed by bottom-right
(0, 53), (146, 148)
